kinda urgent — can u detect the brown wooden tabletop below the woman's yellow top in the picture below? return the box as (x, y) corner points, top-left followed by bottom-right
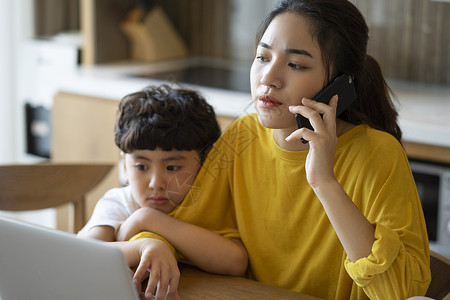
(174, 265), (319, 300)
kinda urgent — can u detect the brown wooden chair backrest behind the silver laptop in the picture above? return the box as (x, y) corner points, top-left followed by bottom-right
(0, 163), (113, 233)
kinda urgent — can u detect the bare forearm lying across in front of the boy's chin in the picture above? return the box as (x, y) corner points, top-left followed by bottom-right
(116, 208), (248, 276)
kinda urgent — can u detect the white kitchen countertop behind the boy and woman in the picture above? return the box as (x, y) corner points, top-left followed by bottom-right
(58, 59), (450, 147)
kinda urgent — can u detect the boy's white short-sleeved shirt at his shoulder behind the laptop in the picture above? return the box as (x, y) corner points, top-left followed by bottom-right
(78, 186), (139, 236)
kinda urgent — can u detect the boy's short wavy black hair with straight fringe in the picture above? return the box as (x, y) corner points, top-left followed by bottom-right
(115, 84), (220, 162)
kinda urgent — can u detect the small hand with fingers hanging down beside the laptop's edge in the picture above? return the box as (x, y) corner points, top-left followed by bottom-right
(133, 238), (180, 300)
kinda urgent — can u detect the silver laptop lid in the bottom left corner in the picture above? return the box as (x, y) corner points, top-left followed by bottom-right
(0, 217), (139, 300)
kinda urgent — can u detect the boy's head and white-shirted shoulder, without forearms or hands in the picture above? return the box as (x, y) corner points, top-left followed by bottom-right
(78, 85), (220, 242)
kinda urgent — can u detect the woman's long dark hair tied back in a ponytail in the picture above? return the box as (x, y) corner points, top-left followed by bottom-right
(255, 0), (402, 142)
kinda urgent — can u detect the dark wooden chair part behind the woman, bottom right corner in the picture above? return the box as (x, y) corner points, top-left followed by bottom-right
(425, 250), (450, 299)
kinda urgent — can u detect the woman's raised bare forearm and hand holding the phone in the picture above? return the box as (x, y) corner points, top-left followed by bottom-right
(286, 96), (374, 262)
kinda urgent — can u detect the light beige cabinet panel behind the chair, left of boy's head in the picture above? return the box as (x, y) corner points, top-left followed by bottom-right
(52, 93), (120, 231)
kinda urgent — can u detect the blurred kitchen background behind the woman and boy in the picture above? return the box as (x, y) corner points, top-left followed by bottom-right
(0, 0), (450, 258)
